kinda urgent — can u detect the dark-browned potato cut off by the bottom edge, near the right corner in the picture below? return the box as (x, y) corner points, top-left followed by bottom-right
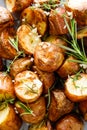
(56, 114), (84, 130)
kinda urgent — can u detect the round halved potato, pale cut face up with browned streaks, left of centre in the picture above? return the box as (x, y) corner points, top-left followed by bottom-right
(14, 70), (43, 103)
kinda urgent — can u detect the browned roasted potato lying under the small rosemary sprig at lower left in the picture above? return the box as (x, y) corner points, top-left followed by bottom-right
(15, 97), (46, 124)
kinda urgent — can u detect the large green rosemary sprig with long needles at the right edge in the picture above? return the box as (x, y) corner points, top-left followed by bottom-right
(60, 17), (87, 64)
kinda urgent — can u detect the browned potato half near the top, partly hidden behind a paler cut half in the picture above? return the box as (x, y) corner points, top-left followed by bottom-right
(21, 7), (47, 36)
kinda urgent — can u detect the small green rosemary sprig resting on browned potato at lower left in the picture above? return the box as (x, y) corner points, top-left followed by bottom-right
(17, 101), (35, 116)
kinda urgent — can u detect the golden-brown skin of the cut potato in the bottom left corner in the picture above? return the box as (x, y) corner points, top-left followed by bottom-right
(0, 105), (22, 130)
